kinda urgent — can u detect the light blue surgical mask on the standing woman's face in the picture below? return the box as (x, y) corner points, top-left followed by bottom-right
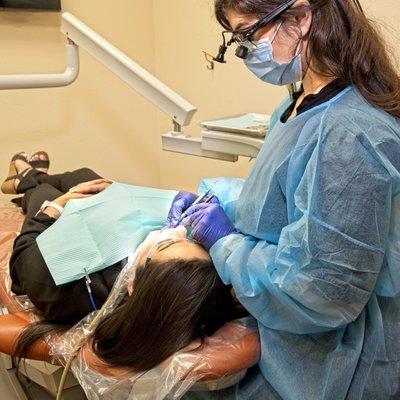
(244, 23), (303, 86)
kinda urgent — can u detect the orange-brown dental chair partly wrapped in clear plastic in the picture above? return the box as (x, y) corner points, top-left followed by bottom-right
(0, 201), (260, 400)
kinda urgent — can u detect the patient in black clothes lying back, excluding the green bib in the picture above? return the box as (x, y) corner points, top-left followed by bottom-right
(2, 153), (236, 371)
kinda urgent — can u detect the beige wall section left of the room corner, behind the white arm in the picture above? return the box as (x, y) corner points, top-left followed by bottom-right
(0, 0), (159, 203)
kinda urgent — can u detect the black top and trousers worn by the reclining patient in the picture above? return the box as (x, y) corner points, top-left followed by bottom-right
(10, 168), (124, 325)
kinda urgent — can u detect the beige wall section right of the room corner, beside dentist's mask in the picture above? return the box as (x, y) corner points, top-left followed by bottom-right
(154, 0), (284, 189)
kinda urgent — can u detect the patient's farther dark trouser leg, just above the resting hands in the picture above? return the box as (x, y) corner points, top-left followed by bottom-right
(17, 168), (101, 193)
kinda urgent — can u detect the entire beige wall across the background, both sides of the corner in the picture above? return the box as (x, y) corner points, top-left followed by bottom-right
(0, 0), (400, 200)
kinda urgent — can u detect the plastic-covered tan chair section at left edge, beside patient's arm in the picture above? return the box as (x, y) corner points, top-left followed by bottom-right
(0, 201), (33, 313)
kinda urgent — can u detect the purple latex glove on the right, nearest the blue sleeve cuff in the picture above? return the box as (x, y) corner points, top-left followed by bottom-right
(182, 203), (236, 251)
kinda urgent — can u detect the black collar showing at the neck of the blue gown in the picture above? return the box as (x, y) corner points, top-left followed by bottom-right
(281, 79), (349, 123)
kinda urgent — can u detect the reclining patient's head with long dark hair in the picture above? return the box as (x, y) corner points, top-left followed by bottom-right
(93, 228), (234, 371)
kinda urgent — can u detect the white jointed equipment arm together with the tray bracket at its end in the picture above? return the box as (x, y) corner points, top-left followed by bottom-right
(0, 12), (263, 162)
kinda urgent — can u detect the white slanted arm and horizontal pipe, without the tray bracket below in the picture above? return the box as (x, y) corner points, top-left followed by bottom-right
(0, 12), (197, 130)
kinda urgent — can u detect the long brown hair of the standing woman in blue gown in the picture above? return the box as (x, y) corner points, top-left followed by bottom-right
(215, 0), (400, 118)
